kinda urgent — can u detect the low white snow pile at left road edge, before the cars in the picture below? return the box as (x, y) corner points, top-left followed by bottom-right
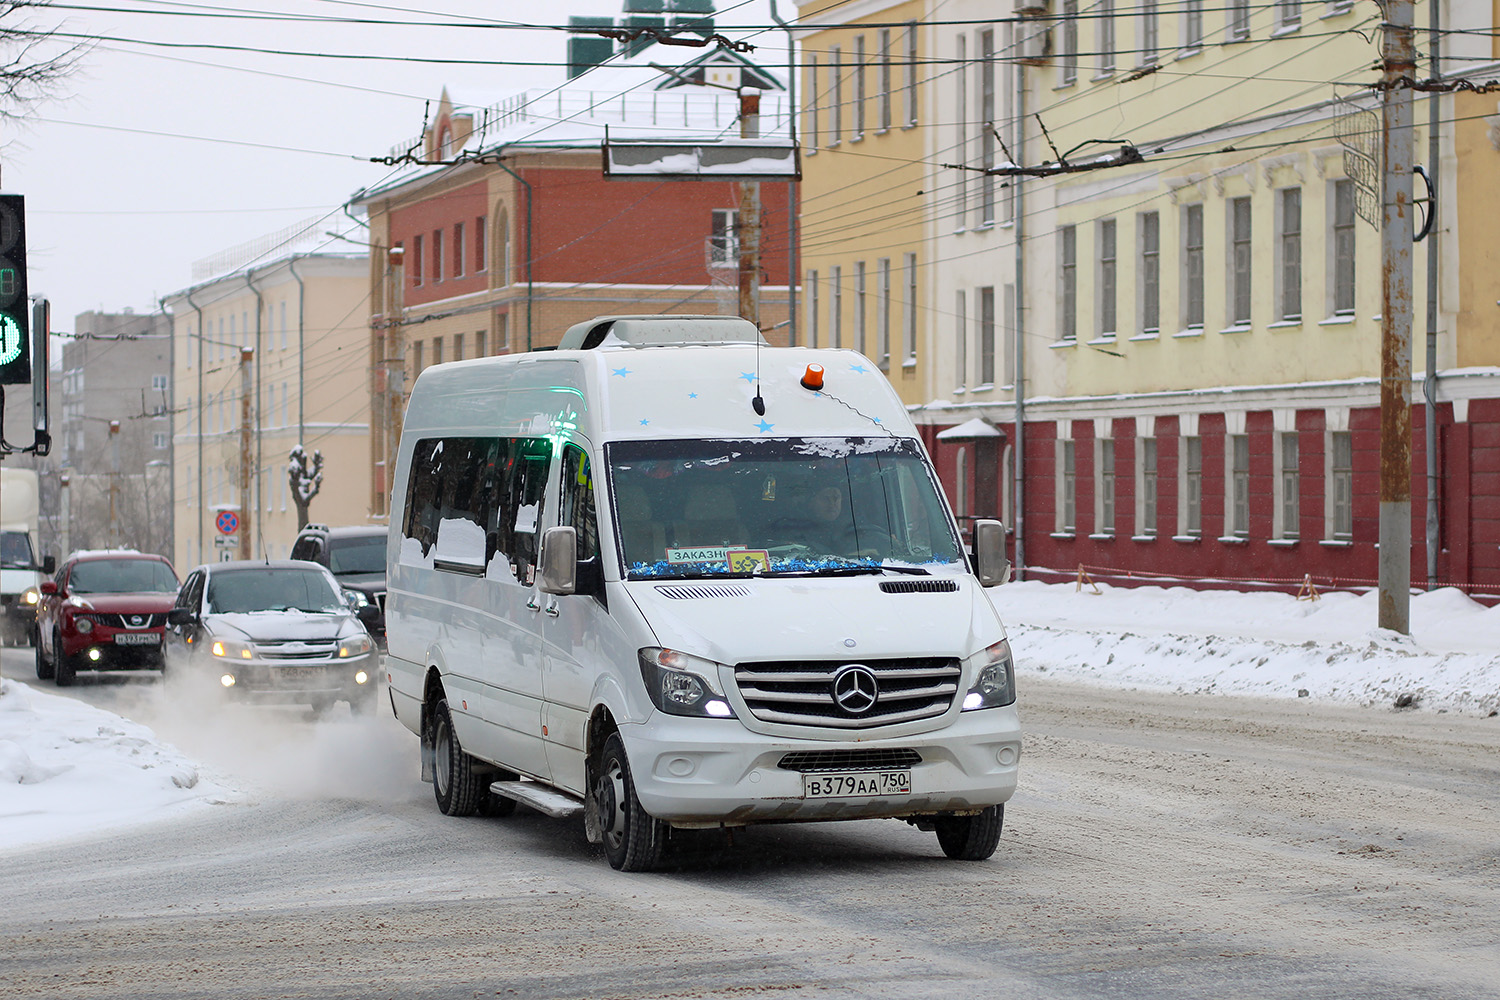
(0, 679), (236, 850)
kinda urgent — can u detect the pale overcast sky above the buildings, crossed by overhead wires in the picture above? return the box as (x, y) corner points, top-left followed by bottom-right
(0, 0), (795, 331)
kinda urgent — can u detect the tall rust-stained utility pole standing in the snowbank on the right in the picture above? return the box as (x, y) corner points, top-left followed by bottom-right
(1379, 0), (1416, 636)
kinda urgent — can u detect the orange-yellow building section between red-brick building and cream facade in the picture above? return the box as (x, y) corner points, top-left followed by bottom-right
(798, 0), (932, 403)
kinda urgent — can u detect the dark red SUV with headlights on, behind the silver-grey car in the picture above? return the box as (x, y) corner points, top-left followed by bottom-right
(36, 550), (177, 688)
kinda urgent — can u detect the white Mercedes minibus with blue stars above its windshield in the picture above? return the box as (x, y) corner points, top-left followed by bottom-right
(386, 316), (1022, 871)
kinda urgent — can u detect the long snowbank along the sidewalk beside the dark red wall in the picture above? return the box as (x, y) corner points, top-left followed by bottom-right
(989, 582), (1500, 715)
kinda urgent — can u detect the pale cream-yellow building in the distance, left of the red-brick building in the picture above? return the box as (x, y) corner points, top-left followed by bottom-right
(164, 253), (369, 573)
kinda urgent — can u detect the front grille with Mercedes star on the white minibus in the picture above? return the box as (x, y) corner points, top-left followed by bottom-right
(735, 657), (960, 729)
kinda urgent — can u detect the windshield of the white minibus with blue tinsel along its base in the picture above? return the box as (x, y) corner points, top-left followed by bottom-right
(605, 438), (965, 580)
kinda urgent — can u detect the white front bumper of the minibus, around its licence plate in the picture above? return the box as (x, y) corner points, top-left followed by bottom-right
(620, 706), (1022, 826)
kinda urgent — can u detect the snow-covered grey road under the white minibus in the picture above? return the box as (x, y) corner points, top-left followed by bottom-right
(0, 651), (1500, 1000)
